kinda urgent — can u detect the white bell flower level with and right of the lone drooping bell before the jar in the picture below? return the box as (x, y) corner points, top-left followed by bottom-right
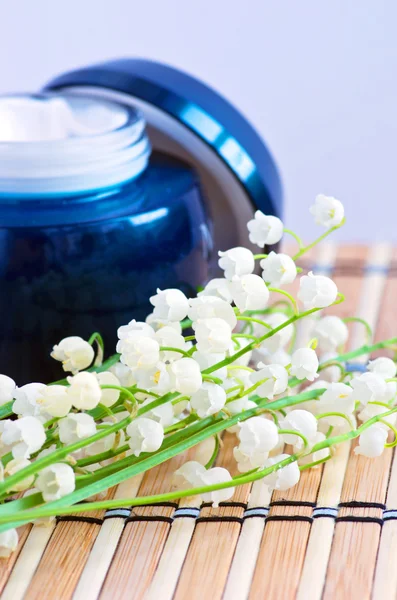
(116, 335), (160, 371)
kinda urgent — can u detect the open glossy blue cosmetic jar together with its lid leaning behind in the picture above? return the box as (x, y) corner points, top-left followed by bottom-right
(0, 59), (282, 385)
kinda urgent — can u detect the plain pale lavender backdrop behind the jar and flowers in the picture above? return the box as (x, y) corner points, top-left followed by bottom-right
(0, 0), (397, 241)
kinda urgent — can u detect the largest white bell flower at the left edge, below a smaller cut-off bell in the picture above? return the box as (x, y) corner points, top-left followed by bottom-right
(1, 416), (46, 458)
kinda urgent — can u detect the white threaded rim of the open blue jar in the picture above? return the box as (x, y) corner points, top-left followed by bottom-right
(0, 93), (151, 198)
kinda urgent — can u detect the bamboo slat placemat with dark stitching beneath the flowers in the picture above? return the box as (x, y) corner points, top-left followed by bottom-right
(0, 244), (397, 600)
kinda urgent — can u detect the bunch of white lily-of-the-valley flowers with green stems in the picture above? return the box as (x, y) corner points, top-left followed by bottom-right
(0, 195), (397, 556)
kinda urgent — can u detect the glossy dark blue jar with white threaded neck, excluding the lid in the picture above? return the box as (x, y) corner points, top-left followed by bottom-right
(0, 95), (212, 385)
